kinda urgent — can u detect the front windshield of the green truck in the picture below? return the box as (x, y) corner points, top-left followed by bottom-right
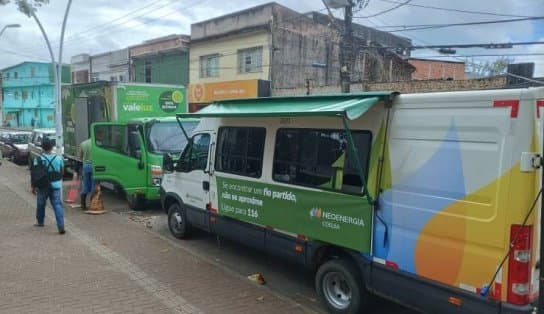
(148, 121), (198, 154)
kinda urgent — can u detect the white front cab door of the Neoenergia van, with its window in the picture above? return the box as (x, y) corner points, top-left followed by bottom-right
(175, 132), (214, 230)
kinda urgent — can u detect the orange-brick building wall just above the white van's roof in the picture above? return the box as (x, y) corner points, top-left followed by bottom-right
(408, 58), (465, 80)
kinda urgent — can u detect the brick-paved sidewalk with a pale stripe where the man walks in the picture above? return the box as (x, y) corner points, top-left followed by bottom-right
(0, 162), (310, 313)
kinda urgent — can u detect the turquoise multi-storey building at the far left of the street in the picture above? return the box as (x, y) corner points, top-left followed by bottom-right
(1, 62), (70, 128)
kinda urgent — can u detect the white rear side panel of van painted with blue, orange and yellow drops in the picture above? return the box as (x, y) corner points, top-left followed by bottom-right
(373, 91), (536, 299)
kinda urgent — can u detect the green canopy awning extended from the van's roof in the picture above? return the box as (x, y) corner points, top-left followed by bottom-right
(177, 92), (397, 120)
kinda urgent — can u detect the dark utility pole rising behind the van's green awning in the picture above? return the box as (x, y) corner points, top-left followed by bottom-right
(340, 0), (353, 93)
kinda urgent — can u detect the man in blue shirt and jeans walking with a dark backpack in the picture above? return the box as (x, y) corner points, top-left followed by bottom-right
(32, 140), (66, 234)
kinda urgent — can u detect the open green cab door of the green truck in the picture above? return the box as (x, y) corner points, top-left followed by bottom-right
(91, 122), (148, 194)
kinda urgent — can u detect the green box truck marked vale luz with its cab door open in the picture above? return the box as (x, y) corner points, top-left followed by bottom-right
(62, 81), (194, 210)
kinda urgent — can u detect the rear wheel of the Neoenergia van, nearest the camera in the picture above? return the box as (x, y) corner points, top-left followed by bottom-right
(315, 259), (368, 314)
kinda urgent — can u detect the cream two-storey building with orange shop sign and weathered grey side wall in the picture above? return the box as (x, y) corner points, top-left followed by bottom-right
(189, 2), (414, 110)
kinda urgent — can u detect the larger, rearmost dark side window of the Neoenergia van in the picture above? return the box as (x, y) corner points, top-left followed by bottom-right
(272, 129), (372, 193)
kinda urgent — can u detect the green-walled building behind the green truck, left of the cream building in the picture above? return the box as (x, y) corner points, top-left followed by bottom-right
(129, 35), (191, 86)
